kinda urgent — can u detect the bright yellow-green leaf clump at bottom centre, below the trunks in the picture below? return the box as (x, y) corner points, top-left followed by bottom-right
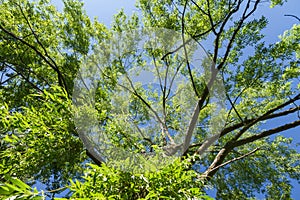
(70, 161), (211, 199)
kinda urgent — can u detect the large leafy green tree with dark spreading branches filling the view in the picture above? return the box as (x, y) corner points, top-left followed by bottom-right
(0, 0), (300, 199)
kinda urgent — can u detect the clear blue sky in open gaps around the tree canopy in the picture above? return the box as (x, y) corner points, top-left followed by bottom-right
(53, 0), (300, 198)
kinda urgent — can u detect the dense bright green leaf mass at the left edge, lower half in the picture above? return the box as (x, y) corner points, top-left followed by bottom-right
(0, 88), (84, 187)
